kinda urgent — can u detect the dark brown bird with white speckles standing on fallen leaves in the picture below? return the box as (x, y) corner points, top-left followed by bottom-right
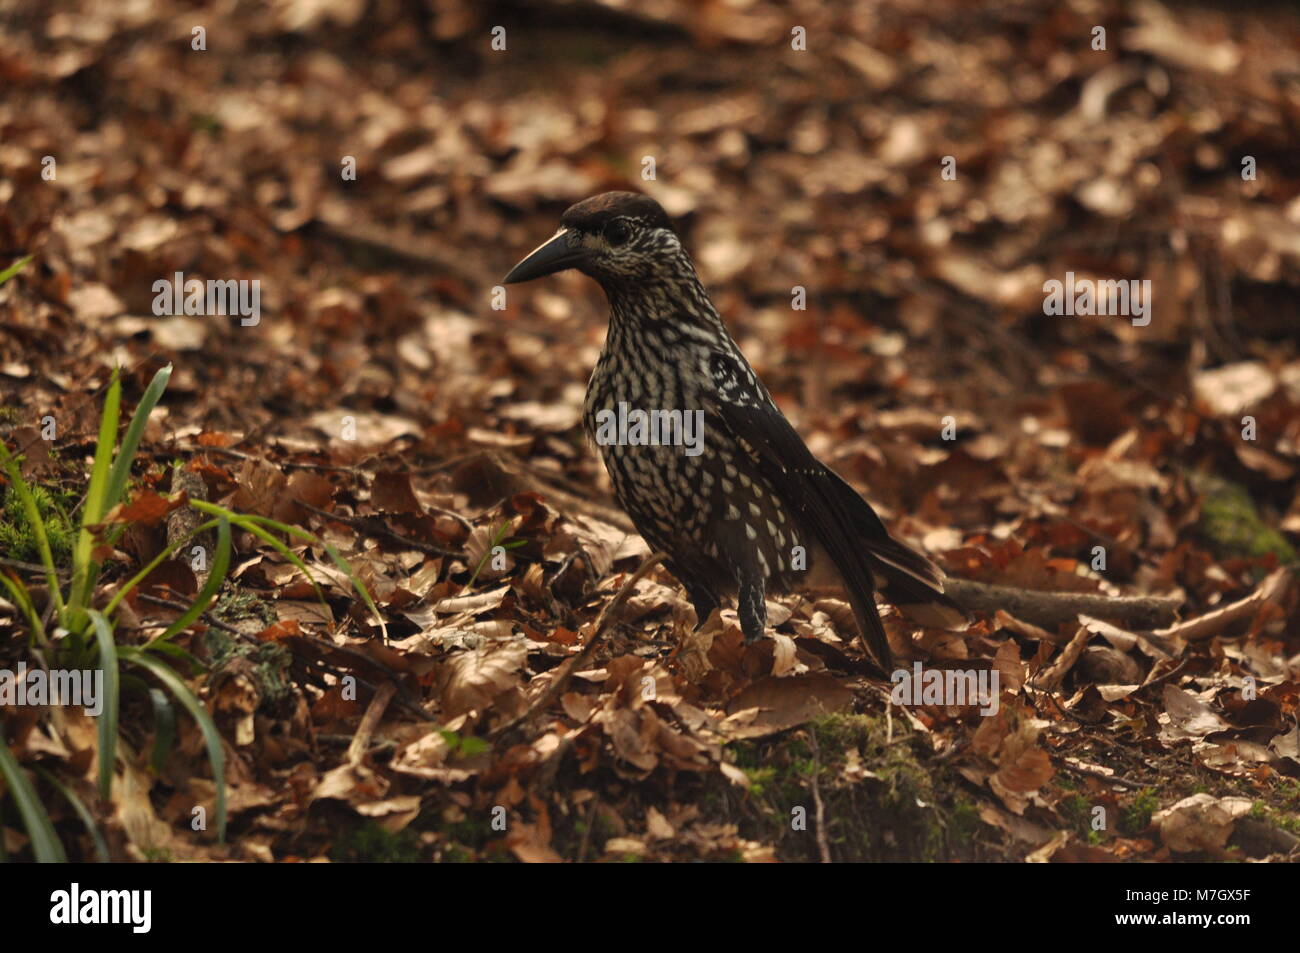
(503, 191), (967, 672)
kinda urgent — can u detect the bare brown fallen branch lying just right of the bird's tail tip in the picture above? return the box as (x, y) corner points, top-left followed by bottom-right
(944, 577), (1183, 629)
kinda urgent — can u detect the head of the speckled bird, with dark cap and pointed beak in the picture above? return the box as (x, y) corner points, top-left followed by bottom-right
(504, 192), (690, 289)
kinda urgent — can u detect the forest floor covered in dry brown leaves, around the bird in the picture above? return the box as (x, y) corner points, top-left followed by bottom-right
(0, 0), (1300, 861)
